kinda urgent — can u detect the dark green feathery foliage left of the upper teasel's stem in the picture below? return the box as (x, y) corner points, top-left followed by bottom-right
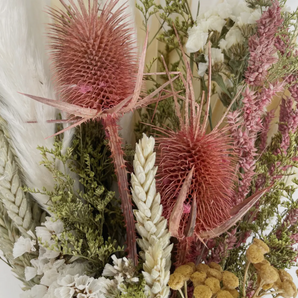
(27, 123), (124, 275)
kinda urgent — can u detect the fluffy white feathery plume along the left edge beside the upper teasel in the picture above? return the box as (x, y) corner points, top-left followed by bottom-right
(0, 0), (70, 208)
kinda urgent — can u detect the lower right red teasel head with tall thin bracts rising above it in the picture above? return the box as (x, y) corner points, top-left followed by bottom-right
(156, 42), (237, 239)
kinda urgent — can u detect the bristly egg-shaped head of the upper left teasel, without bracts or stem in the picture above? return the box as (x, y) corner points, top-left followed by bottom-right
(49, 0), (137, 111)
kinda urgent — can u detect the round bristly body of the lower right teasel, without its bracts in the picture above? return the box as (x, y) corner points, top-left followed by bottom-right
(156, 127), (236, 236)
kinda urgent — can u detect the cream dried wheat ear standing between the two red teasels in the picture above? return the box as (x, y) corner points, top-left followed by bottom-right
(131, 134), (173, 297)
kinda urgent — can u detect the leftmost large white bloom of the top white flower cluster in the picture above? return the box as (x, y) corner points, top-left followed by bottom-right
(185, 26), (208, 53)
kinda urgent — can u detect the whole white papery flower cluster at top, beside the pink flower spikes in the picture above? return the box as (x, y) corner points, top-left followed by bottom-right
(185, 0), (261, 76)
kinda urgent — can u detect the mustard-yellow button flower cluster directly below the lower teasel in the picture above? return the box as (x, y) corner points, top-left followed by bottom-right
(168, 262), (239, 298)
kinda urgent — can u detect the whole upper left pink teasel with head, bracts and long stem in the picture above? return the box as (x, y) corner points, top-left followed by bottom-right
(24, 0), (177, 264)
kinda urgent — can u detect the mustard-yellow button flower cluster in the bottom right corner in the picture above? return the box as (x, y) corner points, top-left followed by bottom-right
(246, 239), (297, 298)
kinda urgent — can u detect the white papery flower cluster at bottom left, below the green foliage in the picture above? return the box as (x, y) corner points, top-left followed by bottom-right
(13, 217), (139, 298)
